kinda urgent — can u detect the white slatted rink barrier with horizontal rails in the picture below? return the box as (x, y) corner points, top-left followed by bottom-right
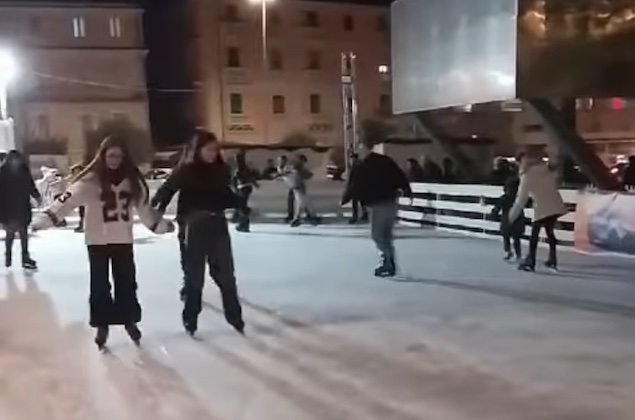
(398, 183), (578, 246)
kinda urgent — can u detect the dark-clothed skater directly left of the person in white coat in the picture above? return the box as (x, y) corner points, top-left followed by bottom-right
(491, 178), (527, 262)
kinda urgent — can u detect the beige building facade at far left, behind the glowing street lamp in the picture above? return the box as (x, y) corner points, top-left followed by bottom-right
(0, 2), (149, 163)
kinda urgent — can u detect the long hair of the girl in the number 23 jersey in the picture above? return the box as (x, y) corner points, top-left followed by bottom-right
(73, 136), (150, 204)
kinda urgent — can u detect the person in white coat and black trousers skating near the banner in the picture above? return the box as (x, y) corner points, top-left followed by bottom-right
(509, 154), (567, 271)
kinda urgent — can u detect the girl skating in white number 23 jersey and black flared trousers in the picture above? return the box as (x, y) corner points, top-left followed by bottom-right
(33, 137), (174, 349)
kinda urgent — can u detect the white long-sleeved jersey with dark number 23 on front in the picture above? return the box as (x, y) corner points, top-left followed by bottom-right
(33, 176), (171, 245)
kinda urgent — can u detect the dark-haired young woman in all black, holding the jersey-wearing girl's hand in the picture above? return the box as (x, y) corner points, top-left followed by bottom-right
(153, 131), (249, 335)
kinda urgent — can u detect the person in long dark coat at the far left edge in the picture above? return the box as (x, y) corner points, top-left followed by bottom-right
(0, 150), (42, 270)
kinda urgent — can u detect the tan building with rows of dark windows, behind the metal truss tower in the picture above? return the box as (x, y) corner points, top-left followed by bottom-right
(179, 0), (391, 146)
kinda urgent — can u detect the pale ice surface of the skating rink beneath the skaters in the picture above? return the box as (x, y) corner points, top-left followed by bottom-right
(0, 224), (635, 420)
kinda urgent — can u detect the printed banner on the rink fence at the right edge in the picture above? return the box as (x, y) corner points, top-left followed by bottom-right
(574, 191), (635, 255)
